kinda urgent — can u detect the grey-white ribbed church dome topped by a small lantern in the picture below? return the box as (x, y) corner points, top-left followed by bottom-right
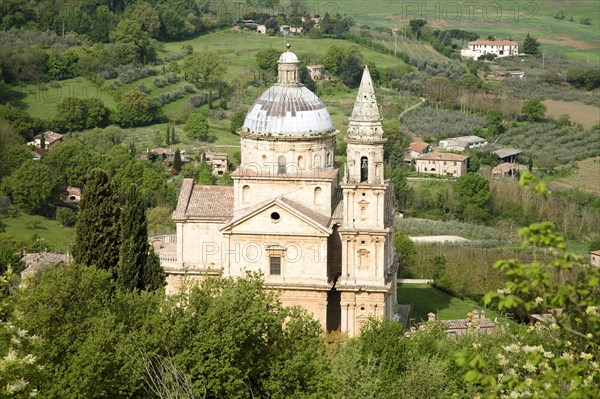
(242, 47), (334, 136)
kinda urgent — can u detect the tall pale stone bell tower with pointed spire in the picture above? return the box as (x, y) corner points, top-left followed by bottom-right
(336, 67), (397, 335)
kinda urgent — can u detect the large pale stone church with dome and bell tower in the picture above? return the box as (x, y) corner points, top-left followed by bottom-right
(159, 45), (397, 336)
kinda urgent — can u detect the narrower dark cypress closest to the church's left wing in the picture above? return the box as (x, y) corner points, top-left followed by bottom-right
(117, 185), (149, 291)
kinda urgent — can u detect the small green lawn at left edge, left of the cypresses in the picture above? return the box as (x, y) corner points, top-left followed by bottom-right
(0, 213), (75, 252)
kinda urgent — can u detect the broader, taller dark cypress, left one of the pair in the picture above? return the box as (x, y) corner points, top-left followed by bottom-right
(73, 169), (121, 276)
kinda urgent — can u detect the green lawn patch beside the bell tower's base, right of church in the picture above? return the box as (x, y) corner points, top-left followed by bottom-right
(398, 284), (506, 322)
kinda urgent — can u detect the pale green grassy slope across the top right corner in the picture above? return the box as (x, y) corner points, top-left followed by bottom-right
(336, 0), (600, 63)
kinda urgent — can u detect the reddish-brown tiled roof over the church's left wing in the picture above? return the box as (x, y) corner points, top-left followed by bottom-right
(173, 179), (233, 220)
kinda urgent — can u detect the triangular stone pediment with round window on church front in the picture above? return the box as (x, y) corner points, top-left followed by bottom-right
(221, 197), (332, 237)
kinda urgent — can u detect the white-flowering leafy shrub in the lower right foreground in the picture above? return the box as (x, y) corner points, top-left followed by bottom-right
(456, 173), (600, 399)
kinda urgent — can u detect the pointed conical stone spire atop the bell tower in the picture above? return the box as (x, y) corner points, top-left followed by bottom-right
(348, 66), (383, 137)
